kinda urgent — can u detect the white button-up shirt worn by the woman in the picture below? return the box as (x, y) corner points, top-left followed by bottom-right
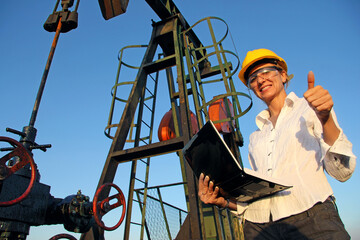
(238, 93), (356, 223)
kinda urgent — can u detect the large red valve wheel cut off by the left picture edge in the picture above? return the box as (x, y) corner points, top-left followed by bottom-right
(0, 137), (36, 206)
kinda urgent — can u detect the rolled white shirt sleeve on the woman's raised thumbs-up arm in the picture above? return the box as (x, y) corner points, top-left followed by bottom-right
(324, 111), (356, 182)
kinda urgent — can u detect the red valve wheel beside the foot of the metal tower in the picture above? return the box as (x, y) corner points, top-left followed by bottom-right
(93, 183), (126, 231)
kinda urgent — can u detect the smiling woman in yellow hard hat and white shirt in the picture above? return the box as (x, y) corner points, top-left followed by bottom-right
(199, 49), (356, 239)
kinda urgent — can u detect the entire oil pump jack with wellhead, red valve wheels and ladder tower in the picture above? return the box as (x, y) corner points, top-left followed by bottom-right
(0, 0), (252, 240)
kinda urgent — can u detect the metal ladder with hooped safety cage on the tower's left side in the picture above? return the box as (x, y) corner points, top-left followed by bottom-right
(105, 45), (161, 239)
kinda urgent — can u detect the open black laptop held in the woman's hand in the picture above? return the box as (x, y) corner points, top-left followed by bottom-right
(182, 121), (291, 202)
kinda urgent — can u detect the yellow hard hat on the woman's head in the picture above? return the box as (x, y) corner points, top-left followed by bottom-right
(239, 48), (287, 86)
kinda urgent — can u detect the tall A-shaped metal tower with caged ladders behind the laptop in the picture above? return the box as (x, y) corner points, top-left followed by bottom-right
(81, 1), (251, 240)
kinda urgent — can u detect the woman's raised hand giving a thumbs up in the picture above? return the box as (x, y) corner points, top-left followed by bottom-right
(304, 71), (334, 125)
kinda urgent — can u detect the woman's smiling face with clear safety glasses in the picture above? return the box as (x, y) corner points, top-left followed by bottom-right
(249, 63), (286, 104)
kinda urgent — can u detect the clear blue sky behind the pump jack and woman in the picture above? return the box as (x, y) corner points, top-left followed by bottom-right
(0, 0), (360, 240)
